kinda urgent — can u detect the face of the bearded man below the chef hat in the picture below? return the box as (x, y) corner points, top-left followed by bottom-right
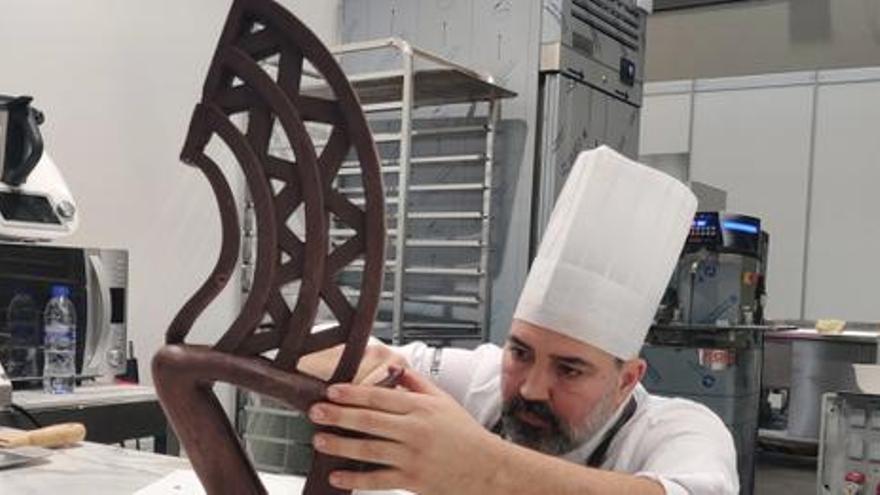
(501, 320), (644, 455)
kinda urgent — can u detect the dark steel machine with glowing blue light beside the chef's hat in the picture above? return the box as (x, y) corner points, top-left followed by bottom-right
(642, 211), (768, 494)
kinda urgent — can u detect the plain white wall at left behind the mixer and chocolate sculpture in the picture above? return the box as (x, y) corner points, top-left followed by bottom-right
(0, 0), (339, 388)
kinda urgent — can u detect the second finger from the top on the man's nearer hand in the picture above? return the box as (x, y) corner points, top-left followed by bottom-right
(309, 402), (407, 440)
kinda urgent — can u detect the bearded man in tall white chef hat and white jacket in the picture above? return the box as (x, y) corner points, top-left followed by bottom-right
(300, 147), (738, 495)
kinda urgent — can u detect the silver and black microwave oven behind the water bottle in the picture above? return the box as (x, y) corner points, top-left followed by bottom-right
(0, 243), (128, 389)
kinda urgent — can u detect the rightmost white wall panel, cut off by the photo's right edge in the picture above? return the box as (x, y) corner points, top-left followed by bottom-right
(805, 80), (880, 321)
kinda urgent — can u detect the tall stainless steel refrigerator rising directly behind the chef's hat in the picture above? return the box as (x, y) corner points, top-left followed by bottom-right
(532, 0), (647, 252)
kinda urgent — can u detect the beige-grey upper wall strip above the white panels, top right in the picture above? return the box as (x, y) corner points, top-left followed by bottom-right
(645, 0), (880, 81)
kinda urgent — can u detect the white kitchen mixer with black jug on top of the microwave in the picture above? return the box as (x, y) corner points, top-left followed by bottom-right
(0, 95), (79, 240)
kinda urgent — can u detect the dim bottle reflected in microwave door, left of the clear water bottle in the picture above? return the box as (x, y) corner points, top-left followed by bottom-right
(6, 292), (40, 379)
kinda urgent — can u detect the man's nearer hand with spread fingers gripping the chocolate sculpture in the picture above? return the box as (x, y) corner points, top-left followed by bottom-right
(309, 367), (502, 495)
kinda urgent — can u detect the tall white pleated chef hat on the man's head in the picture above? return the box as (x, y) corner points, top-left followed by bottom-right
(514, 146), (697, 359)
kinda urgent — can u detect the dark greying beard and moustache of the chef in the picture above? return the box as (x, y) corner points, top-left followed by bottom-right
(501, 391), (616, 455)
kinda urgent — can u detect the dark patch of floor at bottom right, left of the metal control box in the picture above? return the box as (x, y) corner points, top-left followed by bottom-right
(754, 454), (816, 495)
